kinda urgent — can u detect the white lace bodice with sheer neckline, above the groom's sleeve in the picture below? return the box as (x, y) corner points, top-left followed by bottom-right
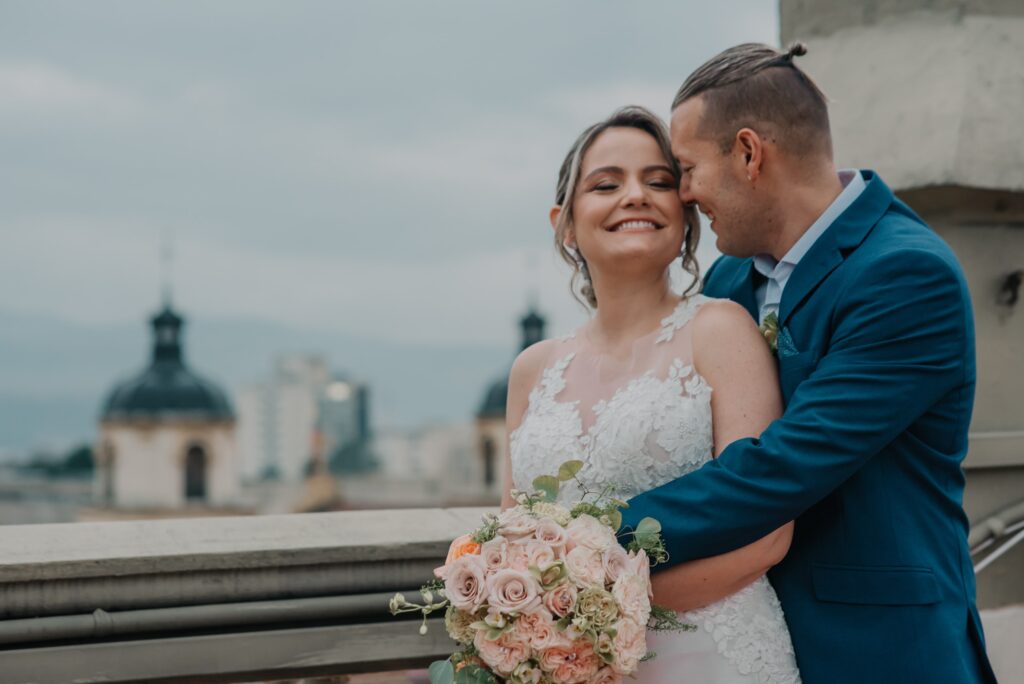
(510, 295), (714, 502)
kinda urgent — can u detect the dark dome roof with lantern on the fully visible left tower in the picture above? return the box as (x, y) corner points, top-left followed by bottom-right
(101, 305), (234, 421)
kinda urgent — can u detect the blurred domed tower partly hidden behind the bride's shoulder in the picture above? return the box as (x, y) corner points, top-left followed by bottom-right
(476, 306), (546, 497)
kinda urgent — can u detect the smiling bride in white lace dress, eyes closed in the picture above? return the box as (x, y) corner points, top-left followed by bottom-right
(503, 106), (800, 684)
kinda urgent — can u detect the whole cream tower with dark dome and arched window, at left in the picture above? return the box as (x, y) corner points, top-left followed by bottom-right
(95, 303), (239, 509)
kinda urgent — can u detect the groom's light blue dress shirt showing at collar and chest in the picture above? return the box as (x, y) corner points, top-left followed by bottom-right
(754, 169), (864, 324)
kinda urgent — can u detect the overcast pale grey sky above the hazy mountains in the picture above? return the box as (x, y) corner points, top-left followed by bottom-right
(0, 0), (778, 345)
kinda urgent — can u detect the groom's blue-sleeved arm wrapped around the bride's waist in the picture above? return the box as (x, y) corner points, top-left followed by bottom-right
(623, 249), (973, 564)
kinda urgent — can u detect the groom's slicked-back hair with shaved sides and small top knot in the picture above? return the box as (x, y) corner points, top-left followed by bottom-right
(672, 43), (831, 158)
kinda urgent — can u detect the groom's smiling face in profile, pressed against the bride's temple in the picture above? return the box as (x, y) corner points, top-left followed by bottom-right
(671, 96), (763, 257)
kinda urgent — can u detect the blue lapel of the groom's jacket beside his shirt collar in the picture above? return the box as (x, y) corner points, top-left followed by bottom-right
(778, 171), (893, 326)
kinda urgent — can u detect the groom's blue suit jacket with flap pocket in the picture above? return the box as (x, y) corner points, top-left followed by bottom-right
(624, 171), (995, 684)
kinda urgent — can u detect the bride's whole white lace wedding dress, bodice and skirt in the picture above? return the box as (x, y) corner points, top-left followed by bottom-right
(511, 295), (800, 684)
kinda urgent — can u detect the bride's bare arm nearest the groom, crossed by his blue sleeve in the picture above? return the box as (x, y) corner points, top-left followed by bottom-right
(652, 301), (793, 610)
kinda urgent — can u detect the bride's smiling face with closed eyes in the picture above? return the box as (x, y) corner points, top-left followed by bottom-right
(572, 128), (683, 272)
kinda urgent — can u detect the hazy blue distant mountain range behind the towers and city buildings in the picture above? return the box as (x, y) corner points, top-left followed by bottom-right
(0, 310), (518, 458)
